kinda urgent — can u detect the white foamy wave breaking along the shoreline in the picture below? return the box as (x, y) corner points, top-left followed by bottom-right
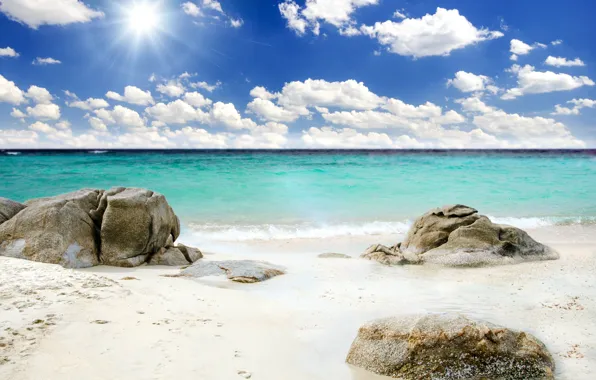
(188, 216), (596, 242)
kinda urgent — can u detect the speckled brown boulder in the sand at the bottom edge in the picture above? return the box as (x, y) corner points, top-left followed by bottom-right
(346, 314), (555, 380)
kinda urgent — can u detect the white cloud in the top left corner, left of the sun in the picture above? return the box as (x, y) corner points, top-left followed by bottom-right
(0, 0), (104, 29)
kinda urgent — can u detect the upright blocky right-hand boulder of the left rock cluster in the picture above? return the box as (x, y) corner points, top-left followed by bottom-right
(100, 187), (180, 267)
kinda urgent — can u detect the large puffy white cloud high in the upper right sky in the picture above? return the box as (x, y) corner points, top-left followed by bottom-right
(361, 8), (503, 58)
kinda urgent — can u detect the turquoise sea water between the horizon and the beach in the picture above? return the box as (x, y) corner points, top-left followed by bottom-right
(0, 152), (596, 238)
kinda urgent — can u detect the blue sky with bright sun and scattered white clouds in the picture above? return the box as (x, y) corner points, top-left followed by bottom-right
(0, 0), (596, 149)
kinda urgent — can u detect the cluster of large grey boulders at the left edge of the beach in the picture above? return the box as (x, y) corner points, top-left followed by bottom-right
(0, 187), (202, 268)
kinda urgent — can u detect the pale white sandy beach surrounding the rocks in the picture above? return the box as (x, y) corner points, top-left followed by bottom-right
(0, 226), (596, 380)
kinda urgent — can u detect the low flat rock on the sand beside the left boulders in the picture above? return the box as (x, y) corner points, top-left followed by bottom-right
(179, 260), (284, 283)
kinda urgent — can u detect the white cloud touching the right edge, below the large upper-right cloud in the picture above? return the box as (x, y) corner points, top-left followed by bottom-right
(501, 65), (594, 100)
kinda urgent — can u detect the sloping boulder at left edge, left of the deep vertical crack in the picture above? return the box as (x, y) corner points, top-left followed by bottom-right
(0, 189), (102, 268)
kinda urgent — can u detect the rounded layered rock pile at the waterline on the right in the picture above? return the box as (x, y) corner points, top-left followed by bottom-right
(362, 205), (559, 266)
